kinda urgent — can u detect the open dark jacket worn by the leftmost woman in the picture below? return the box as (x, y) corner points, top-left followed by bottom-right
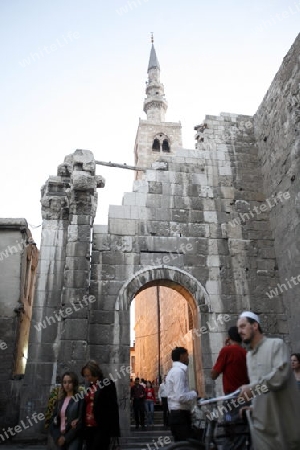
(49, 397), (84, 445)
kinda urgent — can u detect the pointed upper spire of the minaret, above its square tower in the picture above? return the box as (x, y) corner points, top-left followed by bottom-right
(144, 33), (168, 122)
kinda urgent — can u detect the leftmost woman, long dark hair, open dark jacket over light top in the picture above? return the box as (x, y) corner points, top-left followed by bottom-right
(50, 371), (83, 450)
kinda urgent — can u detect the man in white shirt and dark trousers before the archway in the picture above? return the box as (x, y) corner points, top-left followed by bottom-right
(166, 347), (197, 441)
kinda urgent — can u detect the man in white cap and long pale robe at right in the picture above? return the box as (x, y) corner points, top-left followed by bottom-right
(237, 311), (300, 450)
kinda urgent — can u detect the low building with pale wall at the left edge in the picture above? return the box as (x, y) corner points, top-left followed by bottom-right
(0, 219), (38, 429)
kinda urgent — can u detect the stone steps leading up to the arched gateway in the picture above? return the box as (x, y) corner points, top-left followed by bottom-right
(120, 405), (173, 450)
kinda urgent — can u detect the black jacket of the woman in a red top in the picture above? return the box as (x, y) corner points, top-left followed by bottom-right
(83, 378), (120, 437)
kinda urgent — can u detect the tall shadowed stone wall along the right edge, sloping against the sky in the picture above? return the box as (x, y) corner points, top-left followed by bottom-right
(254, 35), (300, 352)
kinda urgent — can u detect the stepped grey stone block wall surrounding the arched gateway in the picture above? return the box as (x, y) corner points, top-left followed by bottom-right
(92, 109), (287, 404)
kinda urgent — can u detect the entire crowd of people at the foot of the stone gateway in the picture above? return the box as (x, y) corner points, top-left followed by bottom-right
(44, 311), (300, 450)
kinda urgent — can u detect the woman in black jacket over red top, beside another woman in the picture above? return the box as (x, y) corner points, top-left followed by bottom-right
(81, 361), (120, 450)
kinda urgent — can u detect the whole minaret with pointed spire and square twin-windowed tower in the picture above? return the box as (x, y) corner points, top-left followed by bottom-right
(134, 35), (182, 179)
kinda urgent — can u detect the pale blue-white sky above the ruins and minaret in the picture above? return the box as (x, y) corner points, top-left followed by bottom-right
(0, 0), (300, 241)
